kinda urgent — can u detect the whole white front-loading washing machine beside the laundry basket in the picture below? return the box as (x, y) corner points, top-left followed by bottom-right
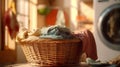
(94, 0), (120, 61)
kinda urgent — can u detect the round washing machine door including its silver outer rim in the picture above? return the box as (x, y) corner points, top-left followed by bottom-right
(98, 4), (120, 50)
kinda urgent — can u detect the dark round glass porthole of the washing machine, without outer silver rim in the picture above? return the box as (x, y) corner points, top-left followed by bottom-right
(100, 5), (120, 45)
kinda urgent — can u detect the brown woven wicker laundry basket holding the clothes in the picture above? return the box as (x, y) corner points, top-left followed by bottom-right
(20, 39), (82, 66)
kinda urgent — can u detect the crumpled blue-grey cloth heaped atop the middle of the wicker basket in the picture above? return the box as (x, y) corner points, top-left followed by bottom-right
(40, 25), (75, 39)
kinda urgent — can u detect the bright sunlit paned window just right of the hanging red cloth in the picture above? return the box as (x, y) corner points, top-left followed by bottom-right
(17, 0), (37, 29)
